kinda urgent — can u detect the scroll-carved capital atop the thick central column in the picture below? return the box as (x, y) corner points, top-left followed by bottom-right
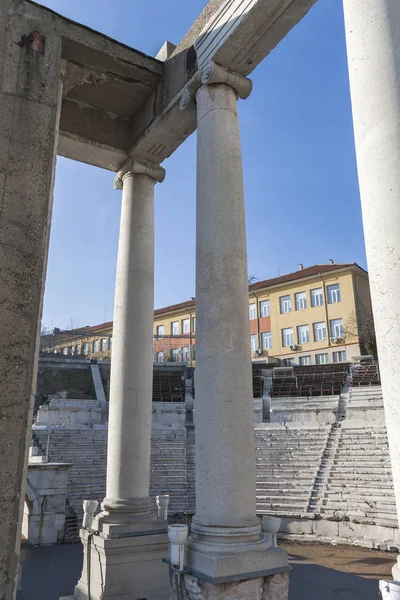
(179, 61), (253, 110)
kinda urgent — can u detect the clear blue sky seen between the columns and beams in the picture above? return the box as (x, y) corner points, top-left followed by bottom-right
(41, 0), (366, 328)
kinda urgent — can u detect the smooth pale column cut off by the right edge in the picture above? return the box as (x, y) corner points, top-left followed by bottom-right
(343, 0), (400, 579)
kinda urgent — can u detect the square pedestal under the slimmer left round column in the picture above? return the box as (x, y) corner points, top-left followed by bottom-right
(60, 522), (170, 600)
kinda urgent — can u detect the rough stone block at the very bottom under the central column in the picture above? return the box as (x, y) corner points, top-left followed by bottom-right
(169, 573), (289, 600)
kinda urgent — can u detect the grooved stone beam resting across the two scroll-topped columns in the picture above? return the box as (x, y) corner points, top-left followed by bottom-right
(131, 0), (316, 162)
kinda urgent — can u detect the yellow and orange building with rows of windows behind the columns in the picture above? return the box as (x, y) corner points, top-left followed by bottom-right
(43, 261), (371, 365)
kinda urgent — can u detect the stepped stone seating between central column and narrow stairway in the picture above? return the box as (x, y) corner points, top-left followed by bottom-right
(255, 424), (331, 516)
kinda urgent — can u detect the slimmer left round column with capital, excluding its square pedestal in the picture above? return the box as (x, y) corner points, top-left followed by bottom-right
(100, 161), (165, 530)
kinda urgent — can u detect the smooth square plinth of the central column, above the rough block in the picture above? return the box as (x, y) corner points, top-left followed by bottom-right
(185, 531), (290, 584)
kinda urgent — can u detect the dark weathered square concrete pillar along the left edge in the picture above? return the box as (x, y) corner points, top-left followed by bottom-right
(0, 0), (61, 600)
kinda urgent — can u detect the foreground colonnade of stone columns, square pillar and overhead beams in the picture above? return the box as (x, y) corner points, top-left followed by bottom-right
(0, 0), (400, 600)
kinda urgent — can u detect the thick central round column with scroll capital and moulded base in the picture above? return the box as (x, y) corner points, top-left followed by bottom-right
(182, 63), (287, 597)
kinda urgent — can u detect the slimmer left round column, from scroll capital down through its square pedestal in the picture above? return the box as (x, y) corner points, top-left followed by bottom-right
(63, 160), (168, 600)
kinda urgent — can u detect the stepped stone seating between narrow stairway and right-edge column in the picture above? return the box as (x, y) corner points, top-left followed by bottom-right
(320, 421), (397, 527)
